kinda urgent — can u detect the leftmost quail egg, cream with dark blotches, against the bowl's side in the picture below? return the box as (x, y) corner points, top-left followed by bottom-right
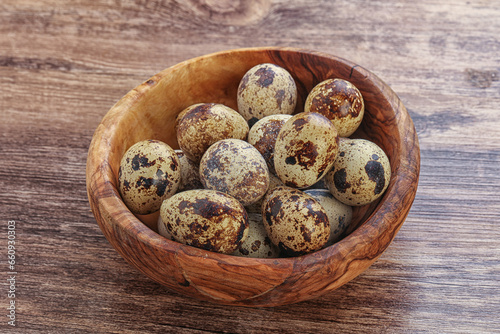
(118, 140), (181, 215)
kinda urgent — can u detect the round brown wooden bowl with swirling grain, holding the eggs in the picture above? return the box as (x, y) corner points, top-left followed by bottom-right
(87, 48), (420, 306)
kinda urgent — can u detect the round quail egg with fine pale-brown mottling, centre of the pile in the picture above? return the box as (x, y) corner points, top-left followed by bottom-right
(200, 139), (269, 206)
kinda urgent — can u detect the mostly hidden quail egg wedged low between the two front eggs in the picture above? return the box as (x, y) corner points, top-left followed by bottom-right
(233, 213), (279, 258)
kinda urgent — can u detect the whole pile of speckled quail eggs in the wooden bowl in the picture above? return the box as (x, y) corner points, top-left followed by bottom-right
(118, 63), (391, 257)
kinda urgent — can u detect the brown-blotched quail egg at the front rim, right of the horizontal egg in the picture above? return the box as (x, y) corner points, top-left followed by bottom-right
(262, 187), (330, 256)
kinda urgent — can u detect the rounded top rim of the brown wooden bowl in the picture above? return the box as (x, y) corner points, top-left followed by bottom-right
(86, 47), (420, 306)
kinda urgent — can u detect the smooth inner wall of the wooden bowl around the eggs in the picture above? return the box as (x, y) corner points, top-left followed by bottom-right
(106, 48), (400, 228)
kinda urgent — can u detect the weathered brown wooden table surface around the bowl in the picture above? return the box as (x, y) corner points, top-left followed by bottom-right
(0, 0), (500, 333)
